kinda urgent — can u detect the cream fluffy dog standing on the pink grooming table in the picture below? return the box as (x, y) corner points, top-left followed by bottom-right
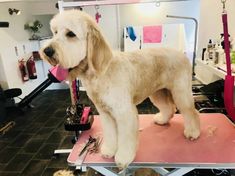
(40, 10), (200, 168)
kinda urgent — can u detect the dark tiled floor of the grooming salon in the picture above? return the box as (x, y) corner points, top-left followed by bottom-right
(0, 90), (157, 176)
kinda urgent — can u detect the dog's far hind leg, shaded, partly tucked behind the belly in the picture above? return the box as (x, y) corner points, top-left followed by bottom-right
(149, 89), (175, 125)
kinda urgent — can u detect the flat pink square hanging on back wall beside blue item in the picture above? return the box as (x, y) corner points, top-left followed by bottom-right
(143, 26), (162, 43)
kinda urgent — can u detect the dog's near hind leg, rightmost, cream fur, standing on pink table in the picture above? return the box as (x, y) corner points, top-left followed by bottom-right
(171, 76), (200, 140)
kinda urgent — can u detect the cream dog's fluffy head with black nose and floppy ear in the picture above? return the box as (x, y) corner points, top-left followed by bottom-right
(40, 10), (111, 74)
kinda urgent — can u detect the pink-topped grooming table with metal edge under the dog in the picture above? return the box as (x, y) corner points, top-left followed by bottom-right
(67, 113), (235, 176)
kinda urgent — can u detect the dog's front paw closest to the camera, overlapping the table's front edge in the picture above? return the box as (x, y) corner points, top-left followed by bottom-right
(115, 151), (135, 169)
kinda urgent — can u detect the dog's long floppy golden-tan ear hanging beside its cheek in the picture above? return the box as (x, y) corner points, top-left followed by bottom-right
(87, 24), (112, 72)
